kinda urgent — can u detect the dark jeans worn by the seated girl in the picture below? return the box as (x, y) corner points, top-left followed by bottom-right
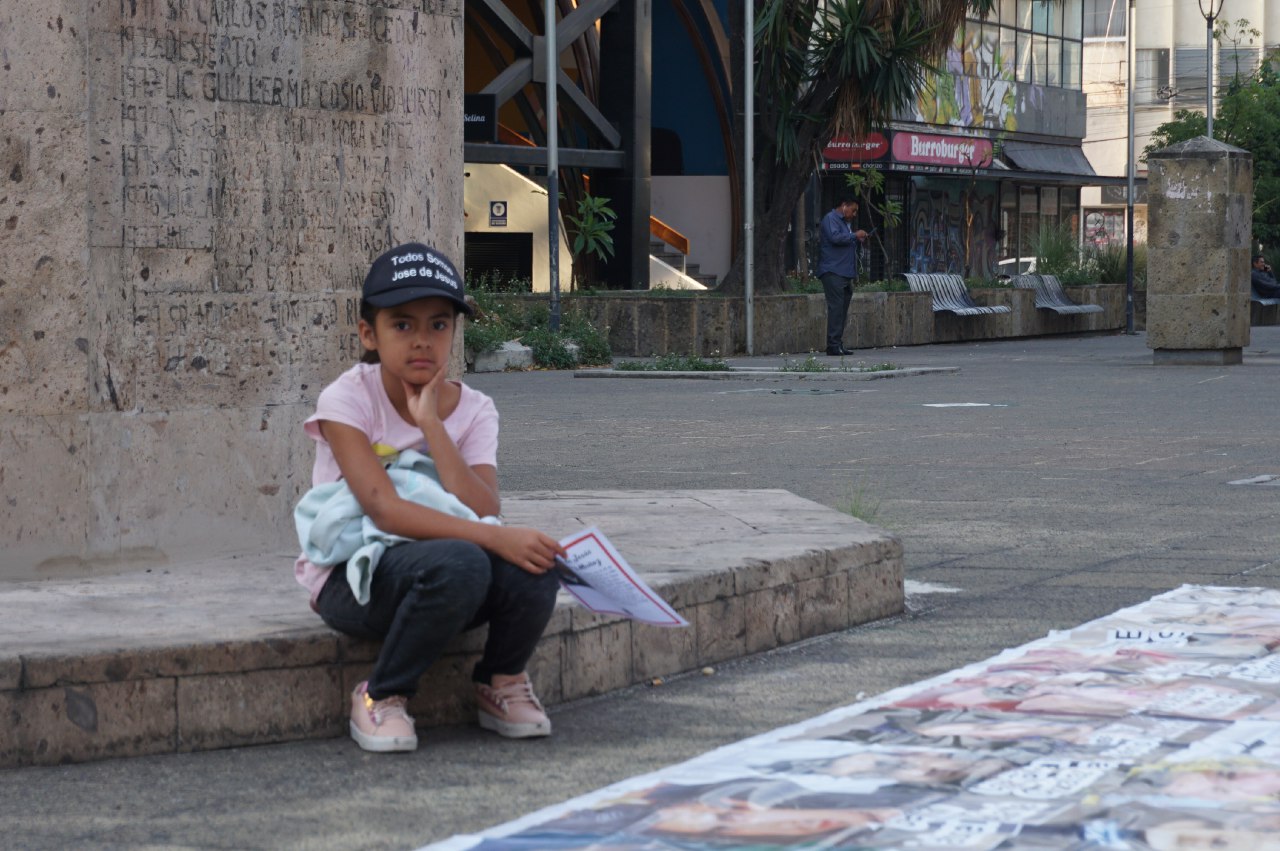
(316, 540), (559, 700)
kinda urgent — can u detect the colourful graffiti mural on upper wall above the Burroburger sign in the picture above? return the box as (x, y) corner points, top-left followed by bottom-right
(914, 28), (1044, 132)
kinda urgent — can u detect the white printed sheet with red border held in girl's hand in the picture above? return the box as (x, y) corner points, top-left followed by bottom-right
(554, 527), (689, 627)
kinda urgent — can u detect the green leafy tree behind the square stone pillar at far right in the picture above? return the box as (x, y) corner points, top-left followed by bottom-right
(1142, 60), (1280, 246)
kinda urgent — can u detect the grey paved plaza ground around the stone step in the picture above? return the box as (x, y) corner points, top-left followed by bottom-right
(0, 328), (1280, 848)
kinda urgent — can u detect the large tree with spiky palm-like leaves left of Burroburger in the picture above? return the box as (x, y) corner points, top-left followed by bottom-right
(721, 0), (995, 293)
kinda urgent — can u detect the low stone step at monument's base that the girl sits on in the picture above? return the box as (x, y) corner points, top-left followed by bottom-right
(0, 490), (904, 768)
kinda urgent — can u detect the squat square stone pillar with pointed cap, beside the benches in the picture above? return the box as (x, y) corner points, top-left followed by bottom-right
(1147, 136), (1253, 363)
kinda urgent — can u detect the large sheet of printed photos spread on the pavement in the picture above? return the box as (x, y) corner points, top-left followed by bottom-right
(429, 586), (1280, 851)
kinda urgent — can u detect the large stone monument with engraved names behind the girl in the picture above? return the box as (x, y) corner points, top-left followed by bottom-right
(0, 0), (463, 580)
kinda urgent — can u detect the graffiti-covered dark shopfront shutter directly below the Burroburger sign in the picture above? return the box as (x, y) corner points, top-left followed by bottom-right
(908, 183), (1000, 276)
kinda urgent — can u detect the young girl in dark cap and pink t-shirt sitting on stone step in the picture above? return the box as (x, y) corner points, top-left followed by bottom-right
(294, 243), (563, 751)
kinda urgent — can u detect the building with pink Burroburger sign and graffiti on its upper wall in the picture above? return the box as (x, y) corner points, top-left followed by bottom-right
(814, 0), (1094, 278)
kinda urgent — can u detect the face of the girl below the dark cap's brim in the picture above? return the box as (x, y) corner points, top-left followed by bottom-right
(360, 297), (456, 386)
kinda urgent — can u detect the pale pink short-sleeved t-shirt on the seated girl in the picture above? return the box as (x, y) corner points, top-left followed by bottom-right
(293, 363), (498, 600)
